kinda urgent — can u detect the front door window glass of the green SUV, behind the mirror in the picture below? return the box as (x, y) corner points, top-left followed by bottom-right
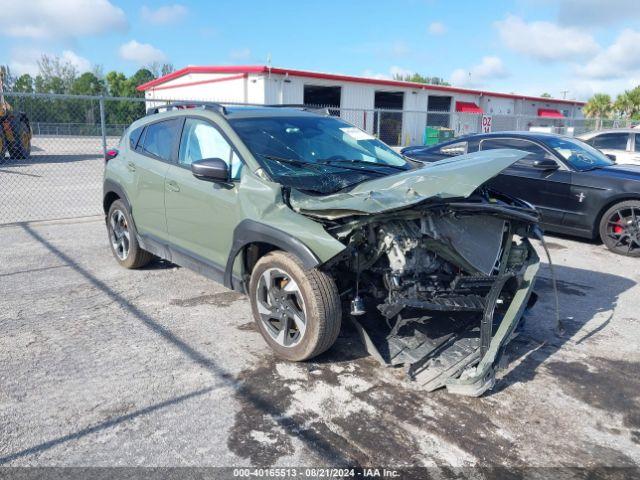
(178, 118), (241, 179)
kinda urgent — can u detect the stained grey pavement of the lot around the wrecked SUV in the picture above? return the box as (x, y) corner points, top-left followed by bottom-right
(0, 217), (640, 467)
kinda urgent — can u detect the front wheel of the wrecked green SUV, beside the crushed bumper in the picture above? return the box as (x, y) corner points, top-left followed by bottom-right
(249, 251), (342, 362)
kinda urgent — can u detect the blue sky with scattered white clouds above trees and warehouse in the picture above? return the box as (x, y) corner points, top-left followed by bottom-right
(0, 0), (640, 99)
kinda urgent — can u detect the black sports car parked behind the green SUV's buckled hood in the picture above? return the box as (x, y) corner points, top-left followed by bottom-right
(402, 132), (640, 257)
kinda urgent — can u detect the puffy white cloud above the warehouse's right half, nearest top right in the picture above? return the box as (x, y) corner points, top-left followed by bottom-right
(495, 15), (600, 61)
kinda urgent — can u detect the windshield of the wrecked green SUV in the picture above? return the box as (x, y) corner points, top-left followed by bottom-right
(229, 116), (412, 193)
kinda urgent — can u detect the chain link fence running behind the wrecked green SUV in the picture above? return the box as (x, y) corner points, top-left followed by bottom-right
(0, 93), (625, 225)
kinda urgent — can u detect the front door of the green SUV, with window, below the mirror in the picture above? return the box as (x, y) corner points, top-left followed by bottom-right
(164, 117), (240, 267)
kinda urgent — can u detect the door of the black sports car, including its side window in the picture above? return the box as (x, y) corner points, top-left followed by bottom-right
(480, 138), (571, 226)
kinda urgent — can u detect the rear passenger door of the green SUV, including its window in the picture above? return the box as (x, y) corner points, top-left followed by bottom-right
(127, 118), (183, 239)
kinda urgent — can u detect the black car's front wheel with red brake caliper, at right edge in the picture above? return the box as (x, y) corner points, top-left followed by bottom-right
(600, 200), (640, 257)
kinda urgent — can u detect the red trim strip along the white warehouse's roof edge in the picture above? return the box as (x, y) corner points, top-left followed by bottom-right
(137, 65), (584, 105)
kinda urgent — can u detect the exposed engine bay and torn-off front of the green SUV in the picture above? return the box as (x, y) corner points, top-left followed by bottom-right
(324, 189), (541, 395)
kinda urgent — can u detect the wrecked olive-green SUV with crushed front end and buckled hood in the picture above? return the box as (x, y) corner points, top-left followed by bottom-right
(104, 104), (541, 395)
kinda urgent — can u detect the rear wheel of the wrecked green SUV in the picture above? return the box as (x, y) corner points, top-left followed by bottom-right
(107, 200), (153, 268)
